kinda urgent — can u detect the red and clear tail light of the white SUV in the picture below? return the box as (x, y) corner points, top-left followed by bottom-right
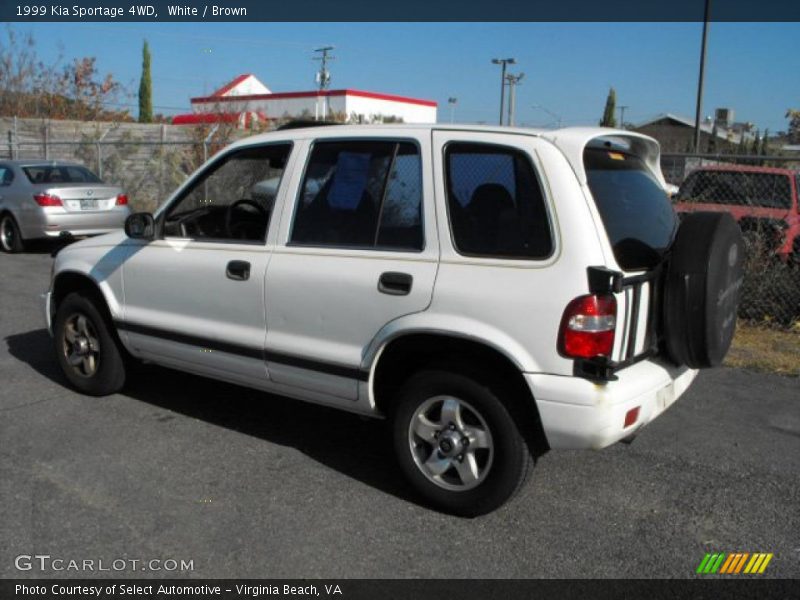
(559, 294), (617, 358)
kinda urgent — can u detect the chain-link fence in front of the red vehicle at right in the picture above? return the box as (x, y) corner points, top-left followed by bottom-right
(662, 154), (800, 327)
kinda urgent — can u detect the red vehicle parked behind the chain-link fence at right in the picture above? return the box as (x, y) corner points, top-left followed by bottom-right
(675, 165), (800, 260)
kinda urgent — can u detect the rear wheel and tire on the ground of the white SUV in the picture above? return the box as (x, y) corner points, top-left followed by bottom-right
(393, 371), (533, 517)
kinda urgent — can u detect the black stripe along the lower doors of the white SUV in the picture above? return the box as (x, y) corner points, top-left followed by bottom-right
(114, 321), (369, 381)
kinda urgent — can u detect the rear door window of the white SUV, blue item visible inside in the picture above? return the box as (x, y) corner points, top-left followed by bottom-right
(290, 141), (423, 251)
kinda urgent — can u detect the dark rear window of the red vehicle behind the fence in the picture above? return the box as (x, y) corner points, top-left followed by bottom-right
(677, 169), (792, 208)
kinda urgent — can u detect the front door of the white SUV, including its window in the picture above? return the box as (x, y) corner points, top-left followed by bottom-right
(120, 143), (291, 384)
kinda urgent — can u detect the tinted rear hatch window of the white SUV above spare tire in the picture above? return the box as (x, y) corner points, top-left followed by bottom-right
(583, 148), (678, 270)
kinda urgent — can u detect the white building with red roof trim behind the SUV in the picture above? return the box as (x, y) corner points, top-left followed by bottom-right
(172, 74), (437, 127)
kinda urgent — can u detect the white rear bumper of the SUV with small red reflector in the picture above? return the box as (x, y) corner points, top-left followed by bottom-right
(525, 360), (697, 449)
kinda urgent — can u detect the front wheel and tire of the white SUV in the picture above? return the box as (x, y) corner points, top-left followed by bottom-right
(54, 292), (125, 396)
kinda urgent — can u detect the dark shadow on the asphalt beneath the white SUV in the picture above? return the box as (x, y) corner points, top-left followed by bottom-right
(5, 329), (418, 503)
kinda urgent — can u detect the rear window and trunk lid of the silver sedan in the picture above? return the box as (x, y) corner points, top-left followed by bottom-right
(23, 164), (127, 213)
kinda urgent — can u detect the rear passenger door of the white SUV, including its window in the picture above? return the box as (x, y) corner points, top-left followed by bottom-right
(266, 135), (439, 400)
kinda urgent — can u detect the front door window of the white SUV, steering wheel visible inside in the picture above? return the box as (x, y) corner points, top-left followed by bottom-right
(164, 144), (291, 242)
